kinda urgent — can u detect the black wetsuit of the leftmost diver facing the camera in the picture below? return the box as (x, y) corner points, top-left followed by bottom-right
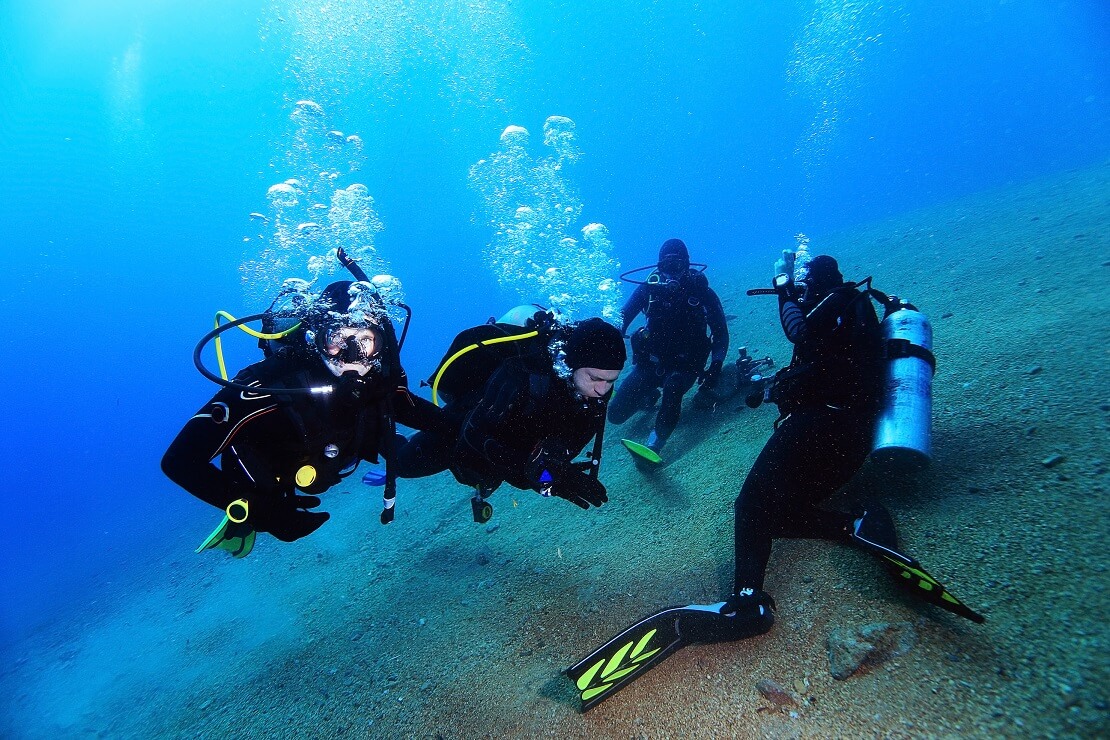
(162, 351), (427, 539)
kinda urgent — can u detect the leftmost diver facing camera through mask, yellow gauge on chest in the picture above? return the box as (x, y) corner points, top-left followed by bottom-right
(162, 254), (435, 557)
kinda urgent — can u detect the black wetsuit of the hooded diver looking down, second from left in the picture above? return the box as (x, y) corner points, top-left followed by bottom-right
(396, 352), (607, 497)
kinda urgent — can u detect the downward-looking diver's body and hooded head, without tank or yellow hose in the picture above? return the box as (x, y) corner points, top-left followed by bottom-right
(395, 318), (626, 516)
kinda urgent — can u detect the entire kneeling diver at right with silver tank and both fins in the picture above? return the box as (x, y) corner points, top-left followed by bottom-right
(566, 255), (983, 710)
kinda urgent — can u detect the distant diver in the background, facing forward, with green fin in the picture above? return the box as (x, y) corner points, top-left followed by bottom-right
(609, 239), (728, 464)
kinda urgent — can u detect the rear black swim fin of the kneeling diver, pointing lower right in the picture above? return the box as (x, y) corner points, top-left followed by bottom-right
(849, 505), (987, 625)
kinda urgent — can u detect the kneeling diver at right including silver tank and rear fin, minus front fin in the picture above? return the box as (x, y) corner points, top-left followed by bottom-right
(727, 255), (982, 627)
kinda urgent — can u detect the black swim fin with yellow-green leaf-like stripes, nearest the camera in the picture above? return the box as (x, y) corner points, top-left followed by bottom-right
(564, 591), (775, 711)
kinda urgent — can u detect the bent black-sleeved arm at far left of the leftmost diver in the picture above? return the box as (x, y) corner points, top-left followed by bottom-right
(162, 377), (279, 509)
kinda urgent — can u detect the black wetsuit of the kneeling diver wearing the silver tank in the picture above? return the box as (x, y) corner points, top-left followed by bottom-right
(735, 285), (881, 592)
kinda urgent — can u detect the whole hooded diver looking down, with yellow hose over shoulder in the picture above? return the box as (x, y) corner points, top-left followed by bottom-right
(395, 315), (626, 523)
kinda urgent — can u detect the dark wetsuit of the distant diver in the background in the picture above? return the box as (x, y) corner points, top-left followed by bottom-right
(609, 270), (728, 445)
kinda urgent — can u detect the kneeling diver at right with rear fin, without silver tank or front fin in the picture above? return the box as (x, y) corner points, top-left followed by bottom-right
(720, 255), (983, 631)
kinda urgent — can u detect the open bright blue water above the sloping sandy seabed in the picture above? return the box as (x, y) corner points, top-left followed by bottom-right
(0, 0), (1110, 642)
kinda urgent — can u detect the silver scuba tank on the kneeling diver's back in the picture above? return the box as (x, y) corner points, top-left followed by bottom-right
(871, 302), (937, 467)
